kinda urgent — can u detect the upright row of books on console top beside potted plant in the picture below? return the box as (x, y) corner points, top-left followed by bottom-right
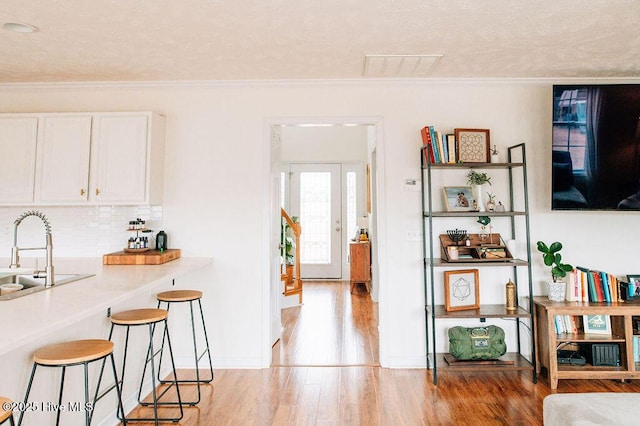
(565, 266), (620, 303)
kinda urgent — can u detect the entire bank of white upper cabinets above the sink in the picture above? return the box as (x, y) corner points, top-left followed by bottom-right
(0, 112), (164, 205)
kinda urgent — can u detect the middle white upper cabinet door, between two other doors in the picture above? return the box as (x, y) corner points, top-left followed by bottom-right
(36, 115), (91, 203)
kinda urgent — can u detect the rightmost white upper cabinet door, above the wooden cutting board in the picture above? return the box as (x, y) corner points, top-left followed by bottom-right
(92, 114), (149, 204)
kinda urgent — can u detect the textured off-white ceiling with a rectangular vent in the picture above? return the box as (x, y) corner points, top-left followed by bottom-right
(0, 0), (640, 83)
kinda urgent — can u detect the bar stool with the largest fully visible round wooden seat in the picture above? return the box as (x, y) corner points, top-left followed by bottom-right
(18, 339), (124, 425)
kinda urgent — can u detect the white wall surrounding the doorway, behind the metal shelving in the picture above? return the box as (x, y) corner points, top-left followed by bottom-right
(0, 81), (640, 367)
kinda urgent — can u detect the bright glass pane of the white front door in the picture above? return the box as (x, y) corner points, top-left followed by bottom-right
(300, 172), (331, 264)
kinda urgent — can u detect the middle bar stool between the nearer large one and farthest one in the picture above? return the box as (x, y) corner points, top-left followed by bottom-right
(109, 308), (183, 424)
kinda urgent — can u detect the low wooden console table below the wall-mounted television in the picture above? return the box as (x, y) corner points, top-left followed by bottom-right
(533, 296), (640, 389)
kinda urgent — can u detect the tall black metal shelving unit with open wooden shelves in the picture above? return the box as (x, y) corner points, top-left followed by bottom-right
(420, 143), (537, 384)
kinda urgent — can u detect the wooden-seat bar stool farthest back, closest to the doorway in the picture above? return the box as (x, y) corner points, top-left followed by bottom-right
(157, 290), (213, 405)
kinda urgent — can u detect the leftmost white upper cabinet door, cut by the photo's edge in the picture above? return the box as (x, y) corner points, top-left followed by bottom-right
(0, 117), (38, 204)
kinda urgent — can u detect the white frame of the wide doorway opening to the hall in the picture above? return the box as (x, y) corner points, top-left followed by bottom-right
(261, 116), (389, 368)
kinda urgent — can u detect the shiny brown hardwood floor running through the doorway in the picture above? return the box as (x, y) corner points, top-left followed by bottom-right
(124, 283), (640, 426)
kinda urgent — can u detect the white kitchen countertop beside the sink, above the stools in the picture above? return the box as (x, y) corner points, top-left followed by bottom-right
(0, 258), (212, 356)
